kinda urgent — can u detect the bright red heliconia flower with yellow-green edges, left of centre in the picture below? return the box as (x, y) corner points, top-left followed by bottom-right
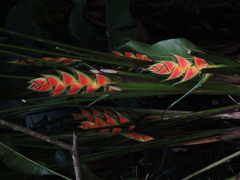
(28, 69), (114, 96)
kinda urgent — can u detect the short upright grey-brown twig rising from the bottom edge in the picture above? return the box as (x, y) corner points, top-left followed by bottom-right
(72, 132), (82, 180)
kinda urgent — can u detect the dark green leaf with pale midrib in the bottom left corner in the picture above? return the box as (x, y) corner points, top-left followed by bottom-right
(0, 137), (70, 180)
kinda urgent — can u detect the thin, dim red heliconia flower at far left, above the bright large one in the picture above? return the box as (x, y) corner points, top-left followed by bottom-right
(9, 57), (82, 66)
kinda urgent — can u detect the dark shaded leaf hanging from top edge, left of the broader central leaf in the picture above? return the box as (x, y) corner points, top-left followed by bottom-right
(69, 0), (92, 47)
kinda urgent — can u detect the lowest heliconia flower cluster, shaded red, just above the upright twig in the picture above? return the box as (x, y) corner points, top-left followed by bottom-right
(72, 108), (154, 142)
